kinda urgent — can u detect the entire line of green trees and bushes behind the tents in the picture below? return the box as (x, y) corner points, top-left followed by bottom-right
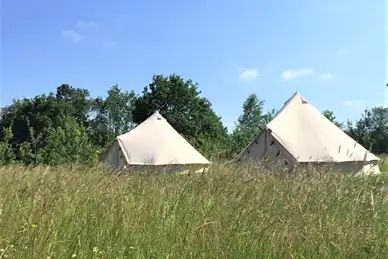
(0, 74), (388, 165)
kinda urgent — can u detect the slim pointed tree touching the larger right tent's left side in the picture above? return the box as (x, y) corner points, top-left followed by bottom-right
(231, 94), (266, 157)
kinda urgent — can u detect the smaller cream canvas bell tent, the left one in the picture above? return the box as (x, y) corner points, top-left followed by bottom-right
(103, 111), (210, 173)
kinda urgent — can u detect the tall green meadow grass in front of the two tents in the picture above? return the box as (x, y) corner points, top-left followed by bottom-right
(0, 166), (388, 259)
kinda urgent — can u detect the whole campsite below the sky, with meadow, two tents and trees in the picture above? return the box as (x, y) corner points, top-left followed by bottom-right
(0, 78), (388, 258)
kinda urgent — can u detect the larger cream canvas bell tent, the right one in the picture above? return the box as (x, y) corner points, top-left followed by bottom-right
(239, 92), (380, 174)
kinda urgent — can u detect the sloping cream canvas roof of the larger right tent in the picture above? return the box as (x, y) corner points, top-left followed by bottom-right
(266, 92), (379, 162)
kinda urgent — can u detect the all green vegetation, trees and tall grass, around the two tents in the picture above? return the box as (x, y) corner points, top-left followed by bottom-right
(0, 74), (388, 258)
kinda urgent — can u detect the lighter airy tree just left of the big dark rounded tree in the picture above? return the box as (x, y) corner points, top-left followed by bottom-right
(89, 85), (136, 147)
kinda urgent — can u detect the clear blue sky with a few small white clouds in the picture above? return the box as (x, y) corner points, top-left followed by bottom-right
(0, 0), (388, 128)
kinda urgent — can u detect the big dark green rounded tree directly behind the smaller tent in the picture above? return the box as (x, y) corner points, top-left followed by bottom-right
(132, 74), (228, 156)
